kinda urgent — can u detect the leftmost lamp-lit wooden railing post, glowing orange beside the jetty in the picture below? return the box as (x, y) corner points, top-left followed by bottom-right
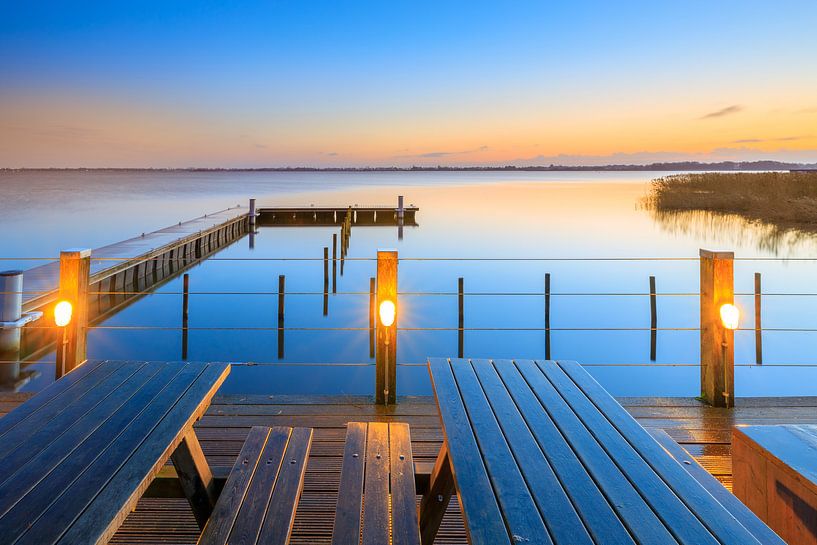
(55, 249), (91, 378)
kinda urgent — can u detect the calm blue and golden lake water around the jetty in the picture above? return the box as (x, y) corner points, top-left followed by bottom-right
(0, 172), (817, 396)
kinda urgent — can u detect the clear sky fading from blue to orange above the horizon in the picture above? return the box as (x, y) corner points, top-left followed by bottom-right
(0, 0), (817, 168)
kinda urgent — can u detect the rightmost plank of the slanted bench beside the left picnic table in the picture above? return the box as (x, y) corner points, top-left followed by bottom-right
(258, 428), (312, 545)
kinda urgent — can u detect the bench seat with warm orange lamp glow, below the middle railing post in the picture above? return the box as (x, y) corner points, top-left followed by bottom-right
(332, 422), (420, 545)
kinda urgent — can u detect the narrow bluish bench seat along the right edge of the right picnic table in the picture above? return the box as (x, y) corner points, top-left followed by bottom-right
(650, 430), (785, 545)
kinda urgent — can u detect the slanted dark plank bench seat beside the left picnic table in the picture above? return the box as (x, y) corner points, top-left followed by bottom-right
(199, 426), (312, 545)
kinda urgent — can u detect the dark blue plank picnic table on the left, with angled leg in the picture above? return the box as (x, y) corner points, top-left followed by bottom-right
(0, 361), (230, 545)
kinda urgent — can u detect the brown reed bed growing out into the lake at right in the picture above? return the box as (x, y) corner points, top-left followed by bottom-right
(642, 172), (817, 231)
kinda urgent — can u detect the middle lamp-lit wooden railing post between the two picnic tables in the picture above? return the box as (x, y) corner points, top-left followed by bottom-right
(375, 250), (398, 405)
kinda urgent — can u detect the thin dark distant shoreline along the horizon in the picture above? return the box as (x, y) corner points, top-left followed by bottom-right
(0, 161), (817, 172)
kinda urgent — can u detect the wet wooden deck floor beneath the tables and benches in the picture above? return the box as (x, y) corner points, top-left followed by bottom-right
(0, 394), (817, 544)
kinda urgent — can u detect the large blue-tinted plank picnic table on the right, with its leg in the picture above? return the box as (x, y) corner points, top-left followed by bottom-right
(420, 359), (783, 545)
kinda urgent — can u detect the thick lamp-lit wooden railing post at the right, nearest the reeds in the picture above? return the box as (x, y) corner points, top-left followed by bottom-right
(700, 250), (735, 407)
